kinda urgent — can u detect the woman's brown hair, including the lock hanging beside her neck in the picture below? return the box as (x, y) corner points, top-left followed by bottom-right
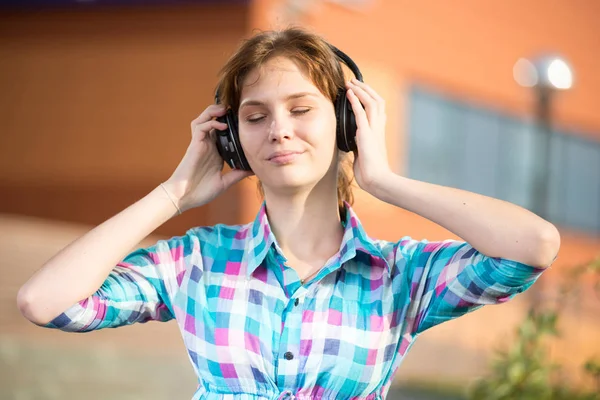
(217, 27), (354, 216)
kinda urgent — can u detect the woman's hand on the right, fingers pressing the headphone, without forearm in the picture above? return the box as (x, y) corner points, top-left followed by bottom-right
(346, 79), (391, 195)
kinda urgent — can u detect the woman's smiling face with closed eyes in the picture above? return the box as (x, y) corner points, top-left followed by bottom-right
(238, 57), (337, 195)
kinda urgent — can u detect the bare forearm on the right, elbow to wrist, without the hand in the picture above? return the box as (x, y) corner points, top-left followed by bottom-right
(373, 173), (560, 268)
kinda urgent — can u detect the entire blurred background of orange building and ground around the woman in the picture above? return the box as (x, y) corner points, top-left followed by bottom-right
(0, 0), (600, 400)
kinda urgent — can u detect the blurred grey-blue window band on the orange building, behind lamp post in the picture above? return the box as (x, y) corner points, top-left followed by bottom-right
(407, 88), (600, 233)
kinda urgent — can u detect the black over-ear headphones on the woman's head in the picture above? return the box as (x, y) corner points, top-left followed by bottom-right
(215, 45), (363, 171)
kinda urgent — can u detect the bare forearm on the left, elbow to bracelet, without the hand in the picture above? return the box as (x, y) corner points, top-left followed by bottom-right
(17, 186), (177, 325)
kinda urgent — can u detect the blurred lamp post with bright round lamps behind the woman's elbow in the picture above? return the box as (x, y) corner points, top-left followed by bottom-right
(513, 56), (573, 309)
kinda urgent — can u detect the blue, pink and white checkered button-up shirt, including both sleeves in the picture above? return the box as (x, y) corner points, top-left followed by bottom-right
(47, 203), (543, 400)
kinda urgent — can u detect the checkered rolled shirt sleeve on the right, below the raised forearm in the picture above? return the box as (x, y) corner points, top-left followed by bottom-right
(394, 237), (544, 334)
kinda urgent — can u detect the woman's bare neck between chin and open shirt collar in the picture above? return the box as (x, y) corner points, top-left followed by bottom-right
(265, 186), (344, 264)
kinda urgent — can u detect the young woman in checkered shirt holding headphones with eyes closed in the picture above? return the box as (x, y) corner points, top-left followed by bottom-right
(18, 29), (560, 400)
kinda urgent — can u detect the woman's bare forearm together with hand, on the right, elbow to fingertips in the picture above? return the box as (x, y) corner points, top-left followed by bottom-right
(347, 80), (560, 268)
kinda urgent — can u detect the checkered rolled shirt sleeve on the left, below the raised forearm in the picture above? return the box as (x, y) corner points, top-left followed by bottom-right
(45, 233), (193, 332)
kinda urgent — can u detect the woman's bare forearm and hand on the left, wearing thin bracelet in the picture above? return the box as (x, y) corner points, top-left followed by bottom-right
(17, 105), (250, 325)
